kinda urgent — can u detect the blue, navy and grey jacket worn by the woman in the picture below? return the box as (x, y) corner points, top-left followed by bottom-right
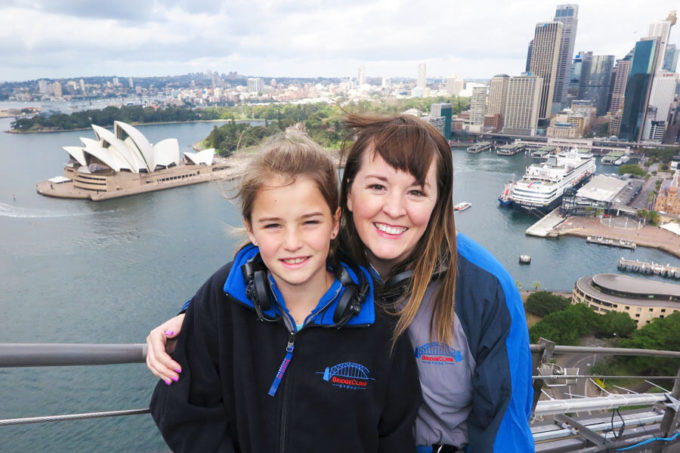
(409, 234), (534, 453)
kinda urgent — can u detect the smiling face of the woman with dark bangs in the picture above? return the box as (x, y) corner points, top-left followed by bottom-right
(347, 149), (437, 276)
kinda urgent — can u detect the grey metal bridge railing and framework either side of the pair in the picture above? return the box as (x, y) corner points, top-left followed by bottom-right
(0, 339), (680, 452)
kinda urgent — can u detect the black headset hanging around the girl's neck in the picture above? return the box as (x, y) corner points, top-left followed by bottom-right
(241, 253), (371, 329)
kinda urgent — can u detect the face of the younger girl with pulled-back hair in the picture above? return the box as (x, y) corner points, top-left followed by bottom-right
(244, 176), (340, 294)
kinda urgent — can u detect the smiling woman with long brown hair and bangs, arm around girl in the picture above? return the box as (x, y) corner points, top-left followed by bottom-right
(147, 115), (534, 452)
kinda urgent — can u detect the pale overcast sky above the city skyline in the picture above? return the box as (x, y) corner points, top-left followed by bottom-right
(0, 0), (680, 81)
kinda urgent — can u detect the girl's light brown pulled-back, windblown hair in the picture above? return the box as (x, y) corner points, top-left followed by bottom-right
(237, 131), (339, 223)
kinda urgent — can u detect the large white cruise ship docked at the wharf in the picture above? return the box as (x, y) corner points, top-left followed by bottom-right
(509, 148), (595, 212)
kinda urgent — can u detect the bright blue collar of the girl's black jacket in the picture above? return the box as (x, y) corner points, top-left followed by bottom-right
(224, 244), (375, 326)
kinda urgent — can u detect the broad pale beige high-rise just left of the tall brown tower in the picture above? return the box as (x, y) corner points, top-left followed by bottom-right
(503, 75), (543, 135)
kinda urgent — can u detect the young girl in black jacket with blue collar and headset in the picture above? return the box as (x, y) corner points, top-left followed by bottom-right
(151, 132), (420, 452)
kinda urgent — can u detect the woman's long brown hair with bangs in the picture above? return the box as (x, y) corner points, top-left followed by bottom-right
(340, 114), (457, 345)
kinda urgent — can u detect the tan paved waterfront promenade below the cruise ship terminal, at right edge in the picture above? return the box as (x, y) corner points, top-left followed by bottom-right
(552, 216), (680, 258)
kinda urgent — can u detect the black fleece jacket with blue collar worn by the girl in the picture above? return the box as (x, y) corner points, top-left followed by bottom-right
(151, 246), (421, 453)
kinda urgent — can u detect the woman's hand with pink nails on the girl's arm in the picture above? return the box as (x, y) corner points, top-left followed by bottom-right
(146, 313), (184, 385)
